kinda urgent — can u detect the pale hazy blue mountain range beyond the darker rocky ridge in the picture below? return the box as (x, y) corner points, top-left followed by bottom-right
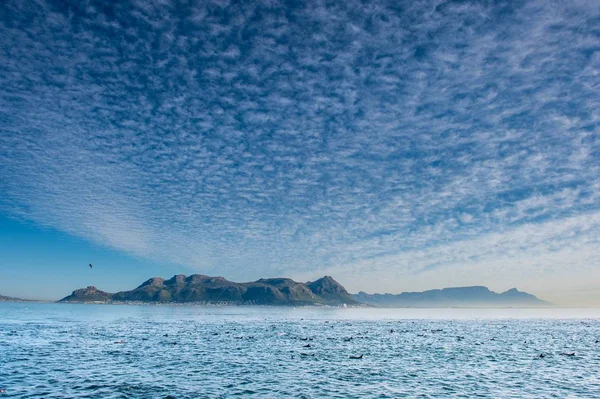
(353, 286), (552, 308)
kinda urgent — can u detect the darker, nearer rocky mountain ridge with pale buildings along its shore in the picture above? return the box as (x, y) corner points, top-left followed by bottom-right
(60, 274), (357, 305)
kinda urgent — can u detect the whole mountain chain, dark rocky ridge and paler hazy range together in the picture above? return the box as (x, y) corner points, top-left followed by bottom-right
(51, 274), (553, 308)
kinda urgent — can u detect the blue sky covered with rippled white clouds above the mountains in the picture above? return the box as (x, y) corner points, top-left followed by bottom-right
(0, 0), (600, 306)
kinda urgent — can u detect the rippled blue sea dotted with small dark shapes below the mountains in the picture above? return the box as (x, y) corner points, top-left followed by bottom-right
(0, 303), (600, 398)
